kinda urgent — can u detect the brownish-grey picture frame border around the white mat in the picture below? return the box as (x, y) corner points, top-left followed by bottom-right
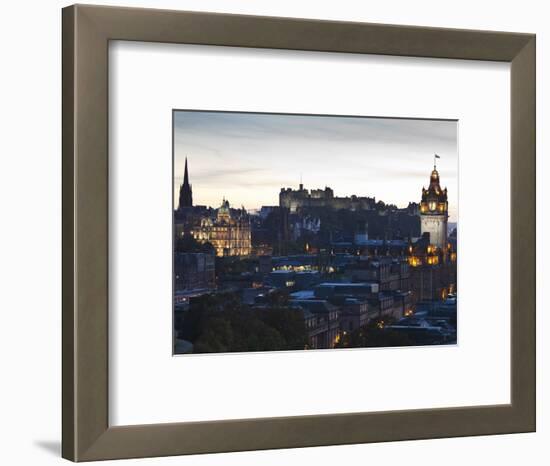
(62, 5), (536, 461)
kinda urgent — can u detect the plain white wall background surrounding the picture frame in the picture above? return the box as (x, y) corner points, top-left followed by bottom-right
(0, 0), (550, 466)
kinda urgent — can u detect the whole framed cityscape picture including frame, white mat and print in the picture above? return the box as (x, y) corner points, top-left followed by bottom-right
(62, 5), (535, 461)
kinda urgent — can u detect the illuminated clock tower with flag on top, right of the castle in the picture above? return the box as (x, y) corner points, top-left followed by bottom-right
(420, 158), (449, 249)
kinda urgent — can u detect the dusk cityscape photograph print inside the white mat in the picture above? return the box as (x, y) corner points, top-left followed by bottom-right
(173, 110), (458, 354)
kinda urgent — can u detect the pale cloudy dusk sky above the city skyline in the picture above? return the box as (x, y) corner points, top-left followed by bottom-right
(174, 111), (458, 222)
